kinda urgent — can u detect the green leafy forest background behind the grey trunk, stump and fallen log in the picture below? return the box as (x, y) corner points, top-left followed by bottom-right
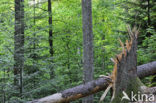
(0, 0), (156, 103)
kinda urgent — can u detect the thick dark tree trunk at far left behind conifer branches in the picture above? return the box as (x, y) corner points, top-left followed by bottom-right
(14, 0), (24, 96)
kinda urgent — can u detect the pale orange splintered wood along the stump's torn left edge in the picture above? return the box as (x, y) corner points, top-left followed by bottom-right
(100, 26), (139, 101)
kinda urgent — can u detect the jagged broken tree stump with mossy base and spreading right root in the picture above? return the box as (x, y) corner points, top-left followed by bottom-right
(111, 28), (156, 103)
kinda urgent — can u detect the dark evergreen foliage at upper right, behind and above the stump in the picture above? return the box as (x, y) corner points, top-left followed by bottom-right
(121, 0), (156, 88)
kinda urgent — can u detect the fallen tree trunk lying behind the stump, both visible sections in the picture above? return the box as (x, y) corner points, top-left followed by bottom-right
(28, 61), (156, 103)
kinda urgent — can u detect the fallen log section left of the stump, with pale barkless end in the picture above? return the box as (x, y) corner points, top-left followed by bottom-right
(28, 78), (111, 103)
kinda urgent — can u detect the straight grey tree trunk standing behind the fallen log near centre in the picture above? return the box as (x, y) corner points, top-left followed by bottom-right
(82, 0), (93, 103)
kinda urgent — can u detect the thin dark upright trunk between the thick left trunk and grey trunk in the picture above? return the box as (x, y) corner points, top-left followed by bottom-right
(48, 0), (54, 79)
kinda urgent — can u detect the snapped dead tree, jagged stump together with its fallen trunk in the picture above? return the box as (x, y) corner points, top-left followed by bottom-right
(28, 28), (156, 103)
